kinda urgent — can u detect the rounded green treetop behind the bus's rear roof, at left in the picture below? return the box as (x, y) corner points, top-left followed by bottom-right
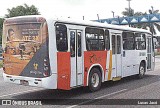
(5, 4), (40, 18)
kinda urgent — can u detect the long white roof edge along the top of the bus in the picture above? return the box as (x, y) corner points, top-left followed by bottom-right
(6, 15), (151, 34)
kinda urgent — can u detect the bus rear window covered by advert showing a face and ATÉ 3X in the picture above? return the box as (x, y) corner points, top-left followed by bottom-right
(5, 23), (41, 42)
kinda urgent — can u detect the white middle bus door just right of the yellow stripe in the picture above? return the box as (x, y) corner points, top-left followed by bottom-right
(112, 34), (122, 80)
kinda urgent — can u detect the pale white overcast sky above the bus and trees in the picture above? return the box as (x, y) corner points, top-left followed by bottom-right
(0, 0), (160, 20)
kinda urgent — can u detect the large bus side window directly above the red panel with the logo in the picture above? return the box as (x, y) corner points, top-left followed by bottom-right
(85, 27), (105, 51)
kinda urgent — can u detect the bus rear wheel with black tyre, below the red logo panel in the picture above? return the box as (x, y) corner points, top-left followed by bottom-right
(88, 68), (102, 92)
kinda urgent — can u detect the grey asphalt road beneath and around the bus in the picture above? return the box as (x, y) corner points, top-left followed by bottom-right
(0, 57), (160, 108)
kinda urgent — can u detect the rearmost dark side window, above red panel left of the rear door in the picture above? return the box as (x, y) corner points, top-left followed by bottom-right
(56, 24), (68, 52)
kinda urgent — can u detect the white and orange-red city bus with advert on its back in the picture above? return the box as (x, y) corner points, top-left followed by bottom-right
(2, 15), (155, 92)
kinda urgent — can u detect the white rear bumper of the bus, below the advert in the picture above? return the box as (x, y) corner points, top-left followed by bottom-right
(3, 73), (57, 89)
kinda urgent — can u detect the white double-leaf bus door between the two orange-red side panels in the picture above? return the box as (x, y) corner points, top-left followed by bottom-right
(69, 30), (82, 87)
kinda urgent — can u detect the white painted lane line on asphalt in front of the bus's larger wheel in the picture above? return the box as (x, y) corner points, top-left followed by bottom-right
(67, 89), (127, 108)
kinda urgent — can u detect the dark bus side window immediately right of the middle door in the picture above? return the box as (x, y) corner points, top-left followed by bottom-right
(122, 32), (135, 50)
